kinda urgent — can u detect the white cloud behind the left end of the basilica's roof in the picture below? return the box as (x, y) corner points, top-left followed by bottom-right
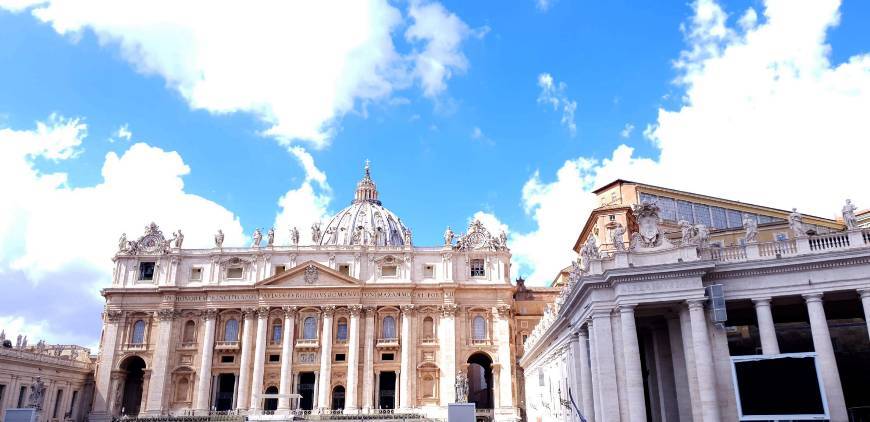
(0, 115), (244, 345)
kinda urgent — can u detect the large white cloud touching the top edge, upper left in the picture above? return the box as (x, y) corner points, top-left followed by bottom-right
(0, 0), (481, 146)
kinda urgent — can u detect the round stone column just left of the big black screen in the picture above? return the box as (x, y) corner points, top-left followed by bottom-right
(687, 299), (721, 422)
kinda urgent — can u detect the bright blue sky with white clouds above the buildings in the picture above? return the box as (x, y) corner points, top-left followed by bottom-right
(0, 0), (870, 344)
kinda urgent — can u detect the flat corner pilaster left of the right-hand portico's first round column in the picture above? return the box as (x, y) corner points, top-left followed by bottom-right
(592, 309), (620, 422)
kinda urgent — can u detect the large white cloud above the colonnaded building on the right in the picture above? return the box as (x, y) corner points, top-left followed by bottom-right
(511, 0), (870, 284)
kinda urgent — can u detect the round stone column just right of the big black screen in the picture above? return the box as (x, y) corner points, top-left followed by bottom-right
(803, 293), (849, 421)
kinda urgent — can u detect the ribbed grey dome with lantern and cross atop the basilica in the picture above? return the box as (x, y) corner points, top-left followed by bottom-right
(320, 161), (411, 246)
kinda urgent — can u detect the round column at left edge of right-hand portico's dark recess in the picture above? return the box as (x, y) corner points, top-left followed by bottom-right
(619, 305), (646, 422)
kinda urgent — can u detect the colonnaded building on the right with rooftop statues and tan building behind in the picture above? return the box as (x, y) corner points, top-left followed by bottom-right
(520, 180), (870, 422)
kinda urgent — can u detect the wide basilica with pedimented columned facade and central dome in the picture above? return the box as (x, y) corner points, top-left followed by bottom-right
(91, 164), (558, 421)
